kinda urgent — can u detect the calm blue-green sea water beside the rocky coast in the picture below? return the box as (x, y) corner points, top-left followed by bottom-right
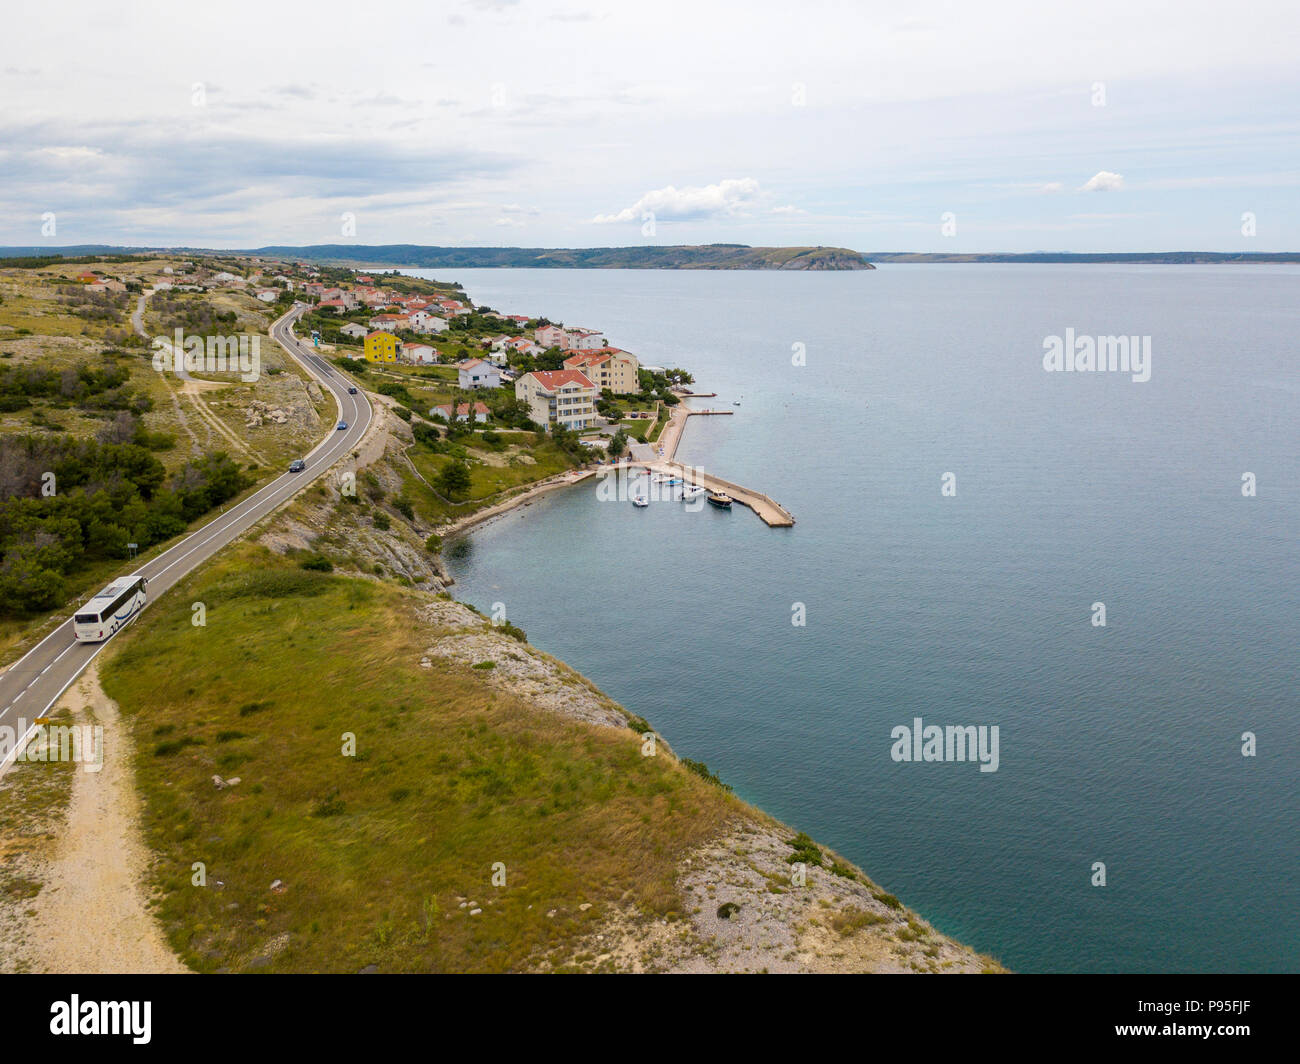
(425, 265), (1300, 972)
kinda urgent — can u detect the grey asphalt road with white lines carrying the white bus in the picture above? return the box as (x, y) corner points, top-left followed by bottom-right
(0, 308), (371, 771)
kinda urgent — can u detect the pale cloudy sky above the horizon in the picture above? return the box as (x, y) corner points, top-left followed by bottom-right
(0, 0), (1300, 252)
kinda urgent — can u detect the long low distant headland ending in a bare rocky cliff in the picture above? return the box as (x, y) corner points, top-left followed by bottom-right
(0, 243), (875, 269)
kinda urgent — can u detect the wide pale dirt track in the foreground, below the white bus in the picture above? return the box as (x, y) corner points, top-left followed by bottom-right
(6, 665), (187, 974)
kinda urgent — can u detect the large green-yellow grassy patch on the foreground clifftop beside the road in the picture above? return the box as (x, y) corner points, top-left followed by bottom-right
(103, 545), (741, 972)
